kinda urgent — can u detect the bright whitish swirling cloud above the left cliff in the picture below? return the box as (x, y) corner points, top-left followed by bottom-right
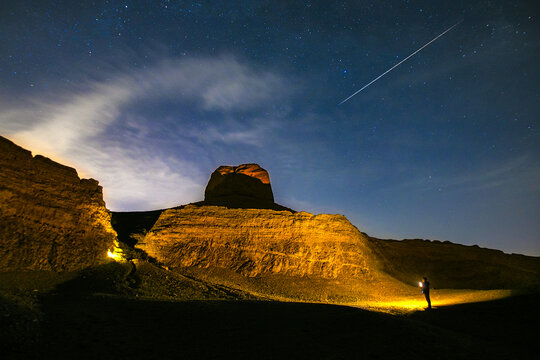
(0, 56), (291, 210)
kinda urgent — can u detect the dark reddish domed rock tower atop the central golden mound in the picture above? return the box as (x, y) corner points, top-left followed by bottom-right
(203, 164), (289, 210)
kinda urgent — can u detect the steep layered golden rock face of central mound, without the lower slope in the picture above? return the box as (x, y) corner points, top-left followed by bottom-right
(136, 206), (374, 279)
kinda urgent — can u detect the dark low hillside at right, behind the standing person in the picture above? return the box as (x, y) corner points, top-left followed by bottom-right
(369, 237), (540, 289)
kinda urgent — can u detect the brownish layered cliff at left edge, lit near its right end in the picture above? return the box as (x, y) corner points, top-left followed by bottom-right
(0, 137), (116, 271)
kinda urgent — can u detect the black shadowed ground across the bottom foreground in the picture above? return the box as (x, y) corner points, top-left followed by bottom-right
(0, 266), (540, 359)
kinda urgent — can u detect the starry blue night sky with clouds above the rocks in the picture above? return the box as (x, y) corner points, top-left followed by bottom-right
(0, 0), (540, 256)
